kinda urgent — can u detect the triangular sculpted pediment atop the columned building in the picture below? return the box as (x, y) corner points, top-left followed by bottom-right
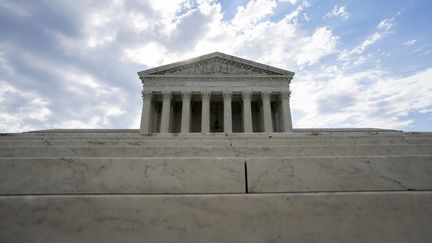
(138, 52), (294, 77)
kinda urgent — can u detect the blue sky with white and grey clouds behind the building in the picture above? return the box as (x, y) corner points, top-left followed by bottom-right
(0, 0), (432, 132)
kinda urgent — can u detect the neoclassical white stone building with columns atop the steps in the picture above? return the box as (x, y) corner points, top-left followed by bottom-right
(138, 52), (294, 134)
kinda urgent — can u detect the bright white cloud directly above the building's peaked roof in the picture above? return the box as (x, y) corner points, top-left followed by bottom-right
(123, 0), (337, 69)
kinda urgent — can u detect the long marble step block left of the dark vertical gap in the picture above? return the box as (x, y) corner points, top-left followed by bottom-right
(0, 158), (246, 195)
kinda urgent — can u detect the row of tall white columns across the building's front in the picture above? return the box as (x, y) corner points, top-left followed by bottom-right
(140, 91), (292, 133)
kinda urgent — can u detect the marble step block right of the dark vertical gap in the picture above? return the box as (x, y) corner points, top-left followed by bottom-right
(247, 155), (432, 192)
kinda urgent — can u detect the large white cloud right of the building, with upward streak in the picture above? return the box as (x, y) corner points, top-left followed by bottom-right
(292, 10), (432, 129)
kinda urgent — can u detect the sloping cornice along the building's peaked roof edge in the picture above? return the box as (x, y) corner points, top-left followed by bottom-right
(138, 52), (295, 78)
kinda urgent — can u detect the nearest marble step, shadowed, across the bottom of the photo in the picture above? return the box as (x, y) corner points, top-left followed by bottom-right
(0, 191), (432, 243)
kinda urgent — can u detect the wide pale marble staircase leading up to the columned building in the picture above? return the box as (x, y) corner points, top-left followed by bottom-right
(0, 129), (432, 243)
